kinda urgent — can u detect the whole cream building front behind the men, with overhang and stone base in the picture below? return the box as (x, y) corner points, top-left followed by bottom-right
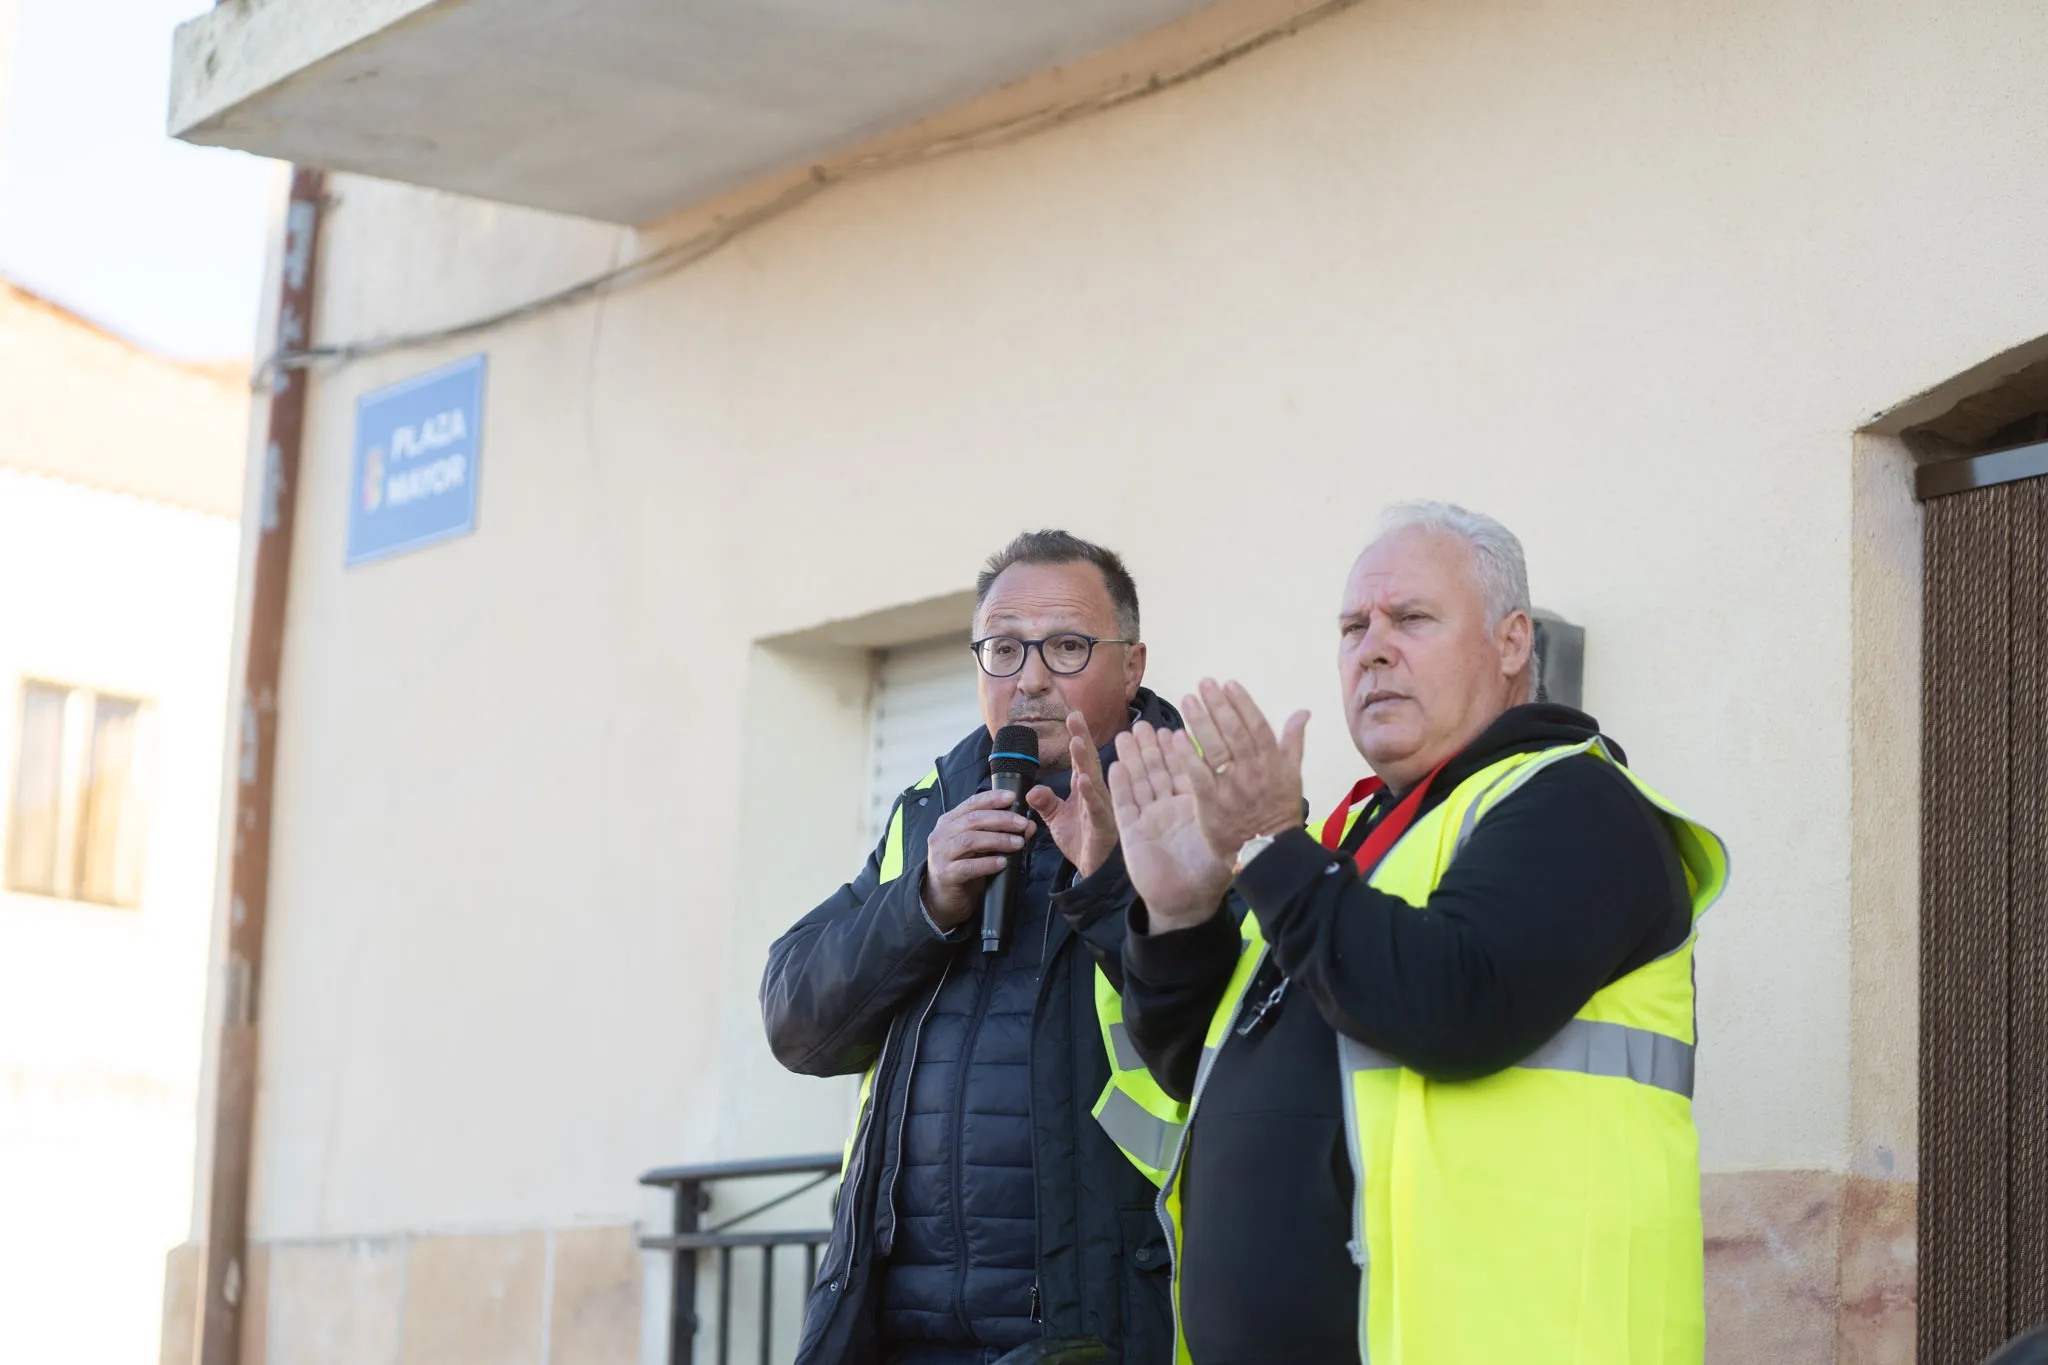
(166, 0), (2048, 1365)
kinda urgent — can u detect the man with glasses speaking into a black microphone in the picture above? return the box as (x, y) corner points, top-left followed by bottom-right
(762, 530), (1180, 1365)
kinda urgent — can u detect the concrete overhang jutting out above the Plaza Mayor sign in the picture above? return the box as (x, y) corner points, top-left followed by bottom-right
(170, 0), (1210, 223)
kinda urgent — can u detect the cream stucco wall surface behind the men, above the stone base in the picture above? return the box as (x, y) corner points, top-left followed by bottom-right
(207, 0), (2048, 1359)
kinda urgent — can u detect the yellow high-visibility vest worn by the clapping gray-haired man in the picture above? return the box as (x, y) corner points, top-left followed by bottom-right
(1098, 739), (1729, 1365)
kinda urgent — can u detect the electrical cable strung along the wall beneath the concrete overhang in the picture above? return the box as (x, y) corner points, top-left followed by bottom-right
(250, 0), (1360, 389)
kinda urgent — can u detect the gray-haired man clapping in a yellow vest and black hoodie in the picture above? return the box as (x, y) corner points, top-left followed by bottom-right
(1102, 503), (1726, 1365)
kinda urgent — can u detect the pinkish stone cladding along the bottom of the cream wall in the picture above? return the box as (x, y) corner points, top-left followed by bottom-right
(162, 1171), (1915, 1365)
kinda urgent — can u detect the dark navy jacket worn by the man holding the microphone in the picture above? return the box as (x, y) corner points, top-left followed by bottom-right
(762, 690), (1180, 1365)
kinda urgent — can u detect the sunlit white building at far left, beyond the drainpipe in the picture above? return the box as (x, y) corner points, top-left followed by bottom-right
(0, 280), (248, 1361)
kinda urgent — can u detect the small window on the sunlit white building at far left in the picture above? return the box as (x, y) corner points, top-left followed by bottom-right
(6, 681), (150, 907)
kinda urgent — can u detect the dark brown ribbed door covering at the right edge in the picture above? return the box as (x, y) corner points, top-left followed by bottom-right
(1919, 477), (2048, 1365)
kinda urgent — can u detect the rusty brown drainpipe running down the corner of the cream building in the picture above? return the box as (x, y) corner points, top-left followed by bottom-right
(193, 166), (326, 1365)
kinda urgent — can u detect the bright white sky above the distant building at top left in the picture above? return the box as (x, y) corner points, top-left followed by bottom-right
(0, 0), (283, 360)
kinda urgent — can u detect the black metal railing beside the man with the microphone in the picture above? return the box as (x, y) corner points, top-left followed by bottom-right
(641, 1152), (840, 1365)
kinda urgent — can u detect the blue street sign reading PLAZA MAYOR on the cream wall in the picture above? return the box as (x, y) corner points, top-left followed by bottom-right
(348, 356), (483, 565)
